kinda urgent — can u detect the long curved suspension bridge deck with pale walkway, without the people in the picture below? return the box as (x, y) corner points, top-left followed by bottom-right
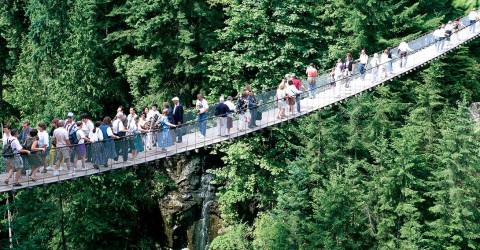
(0, 15), (480, 193)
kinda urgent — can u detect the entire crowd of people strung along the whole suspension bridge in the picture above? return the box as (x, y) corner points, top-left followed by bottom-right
(2, 10), (480, 186)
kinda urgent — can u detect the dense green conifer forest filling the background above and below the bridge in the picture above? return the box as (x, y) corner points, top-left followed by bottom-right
(0, 0), (480, 250)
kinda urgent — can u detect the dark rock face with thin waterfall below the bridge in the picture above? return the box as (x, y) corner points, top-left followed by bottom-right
(159, 155), (221, 250)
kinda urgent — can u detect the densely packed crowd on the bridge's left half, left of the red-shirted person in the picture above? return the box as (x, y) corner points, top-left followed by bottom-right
(2, 85), (259, 186)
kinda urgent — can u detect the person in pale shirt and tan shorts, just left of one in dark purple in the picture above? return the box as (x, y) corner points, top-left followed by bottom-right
(53, 120), (72, 176)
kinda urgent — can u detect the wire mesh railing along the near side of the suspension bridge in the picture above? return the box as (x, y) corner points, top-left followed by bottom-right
(0, 14), (478, 192)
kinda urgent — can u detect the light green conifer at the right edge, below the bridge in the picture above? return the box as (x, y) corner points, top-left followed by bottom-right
(425, 106), (480, 249)
